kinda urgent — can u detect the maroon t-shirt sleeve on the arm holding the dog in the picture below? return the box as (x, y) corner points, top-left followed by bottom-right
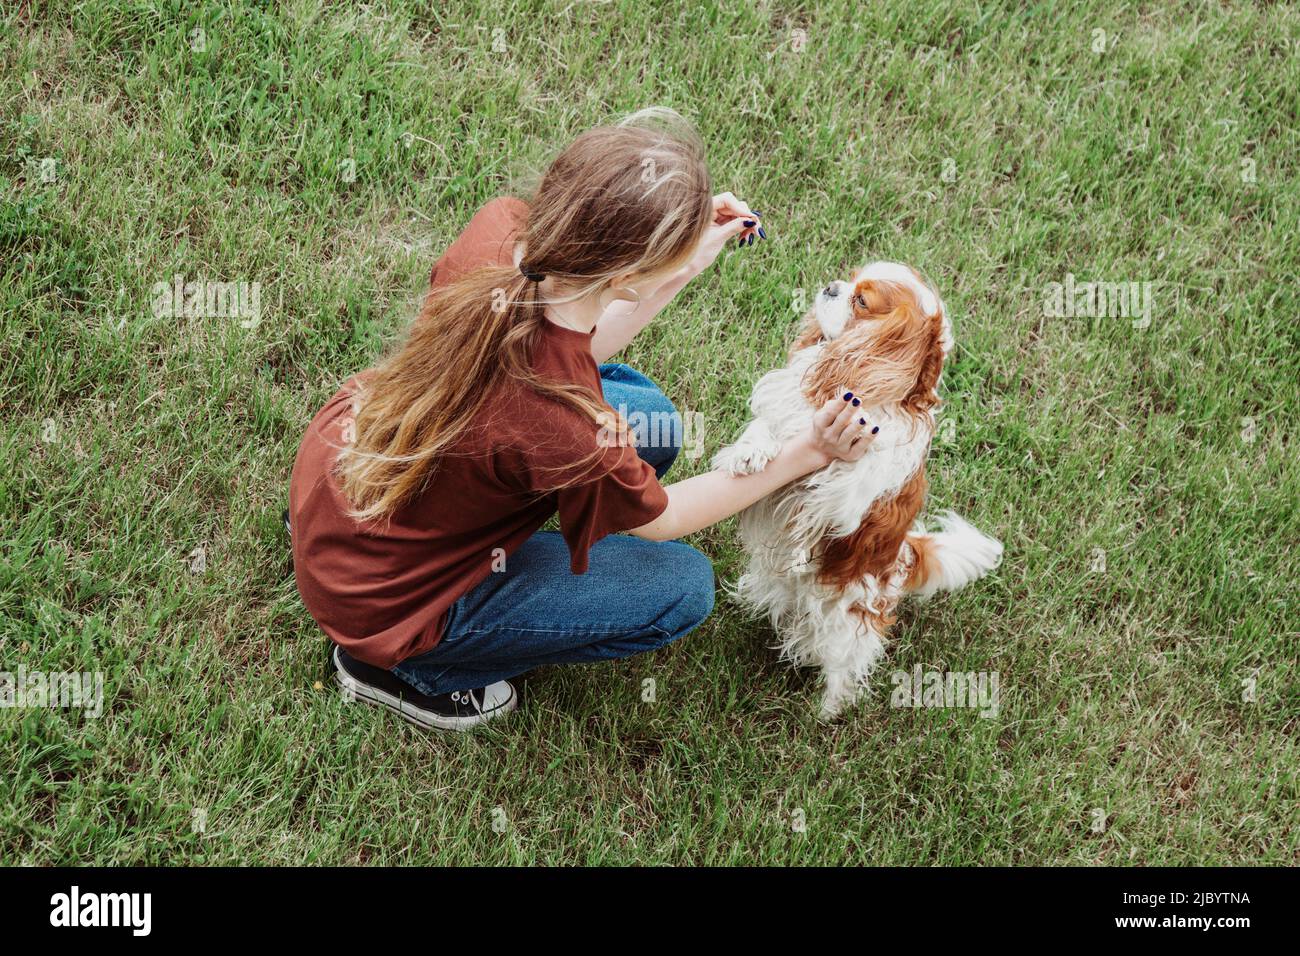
(555, 446), (668, 575)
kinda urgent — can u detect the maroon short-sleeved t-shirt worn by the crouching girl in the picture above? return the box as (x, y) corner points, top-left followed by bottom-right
(289, 199), (668, 667)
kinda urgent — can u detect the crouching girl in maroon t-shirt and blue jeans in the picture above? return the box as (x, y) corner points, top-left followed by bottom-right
(290, 109), (870, 730)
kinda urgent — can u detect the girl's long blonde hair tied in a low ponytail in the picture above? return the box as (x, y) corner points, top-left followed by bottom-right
(337, 108), (712, 520)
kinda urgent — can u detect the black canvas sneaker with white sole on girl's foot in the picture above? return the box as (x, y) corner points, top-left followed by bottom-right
(330, 645), (519, 730)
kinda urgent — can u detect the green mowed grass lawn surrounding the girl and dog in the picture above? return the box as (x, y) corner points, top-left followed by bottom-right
(0, 0), (1300, 865)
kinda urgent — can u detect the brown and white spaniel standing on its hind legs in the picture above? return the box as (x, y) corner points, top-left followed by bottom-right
(714, 263), (1002, 719)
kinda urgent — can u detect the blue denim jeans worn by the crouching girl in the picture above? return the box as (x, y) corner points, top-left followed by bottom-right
(393, 364), (714, 696)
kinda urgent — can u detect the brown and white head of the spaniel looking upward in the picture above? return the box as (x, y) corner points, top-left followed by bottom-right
(794, 263), (953, 414)
